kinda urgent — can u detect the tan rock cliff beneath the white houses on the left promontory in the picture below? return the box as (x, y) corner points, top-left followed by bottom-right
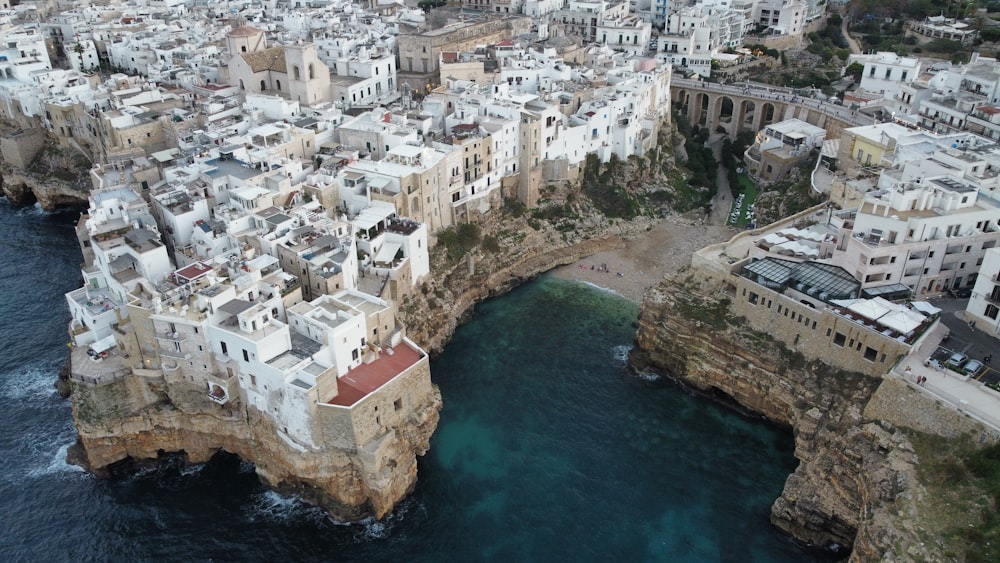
(70, 377), (441, 521)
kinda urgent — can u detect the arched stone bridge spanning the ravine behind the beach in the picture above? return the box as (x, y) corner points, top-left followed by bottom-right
(670, 78), (875, 139)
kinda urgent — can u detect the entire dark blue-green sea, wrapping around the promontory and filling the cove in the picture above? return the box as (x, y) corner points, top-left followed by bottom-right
(0, 198), (820, 563)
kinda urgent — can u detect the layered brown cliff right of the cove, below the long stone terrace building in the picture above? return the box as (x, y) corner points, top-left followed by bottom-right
(630, 275), (941, 561)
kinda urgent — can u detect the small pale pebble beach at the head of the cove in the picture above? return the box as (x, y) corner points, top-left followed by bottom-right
(552, 217), (737, 303)
